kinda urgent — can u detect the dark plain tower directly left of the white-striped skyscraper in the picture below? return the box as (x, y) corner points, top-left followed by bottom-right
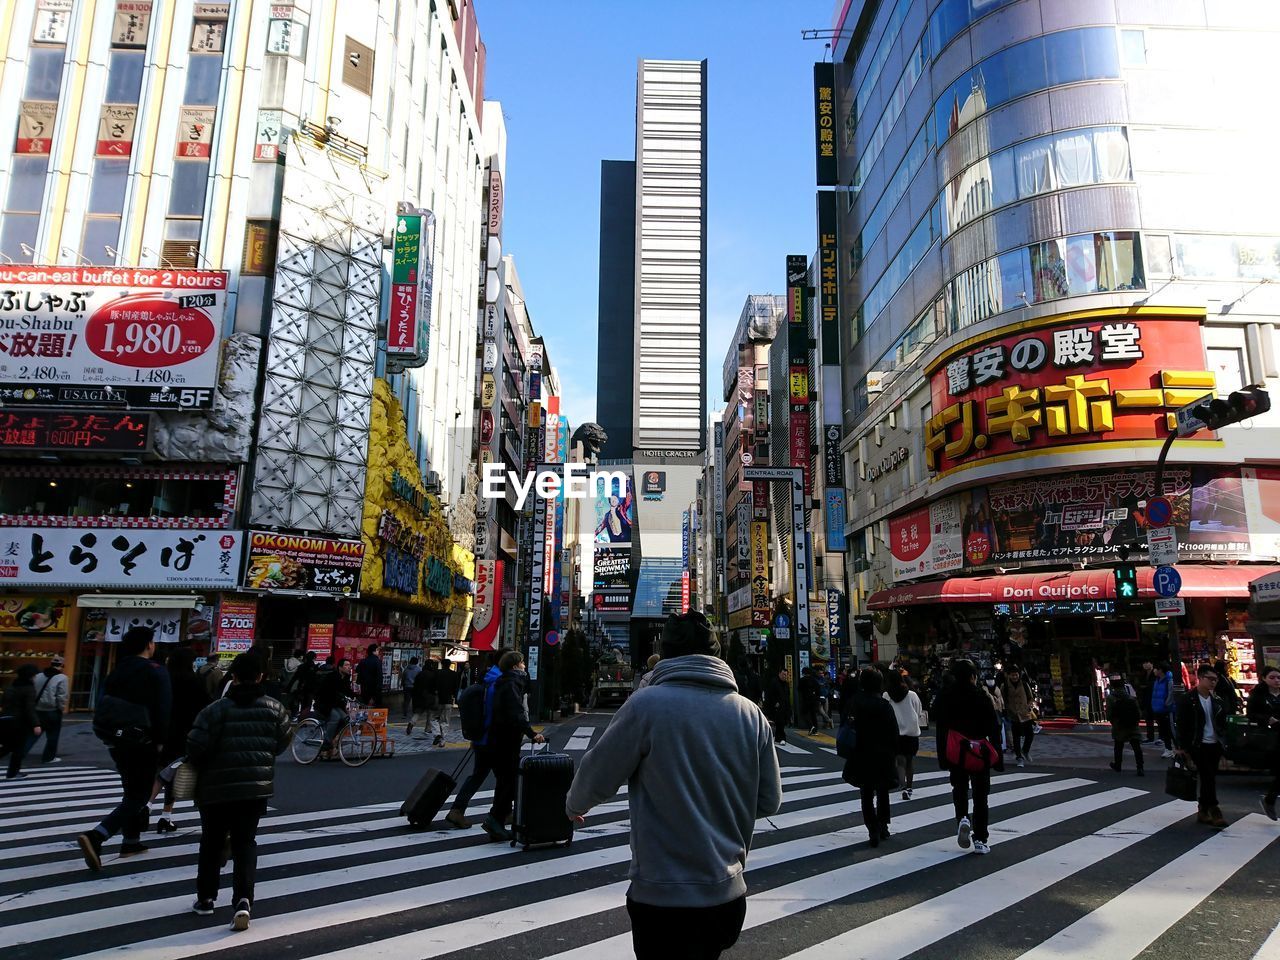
(595, 160), (636, 460)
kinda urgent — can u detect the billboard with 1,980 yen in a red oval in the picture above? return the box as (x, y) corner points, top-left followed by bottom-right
(0, 266), (227, 410)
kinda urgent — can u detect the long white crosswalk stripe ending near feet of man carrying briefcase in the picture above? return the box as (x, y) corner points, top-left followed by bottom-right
(788, 800), (1187, 960)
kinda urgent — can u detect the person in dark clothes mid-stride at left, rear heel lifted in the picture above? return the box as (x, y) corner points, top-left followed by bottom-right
(76, 627), (173, 872)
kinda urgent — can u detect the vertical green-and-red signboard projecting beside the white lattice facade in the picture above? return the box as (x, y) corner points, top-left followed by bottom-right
(387, 204), (435, 372)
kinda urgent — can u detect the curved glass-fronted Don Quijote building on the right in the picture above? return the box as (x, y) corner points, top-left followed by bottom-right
(815, 0), (1280, 696)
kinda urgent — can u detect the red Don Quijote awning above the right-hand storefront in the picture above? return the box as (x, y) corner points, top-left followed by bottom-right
(867, 563), (1280, 611)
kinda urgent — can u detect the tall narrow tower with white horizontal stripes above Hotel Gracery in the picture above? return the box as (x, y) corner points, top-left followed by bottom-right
(632, 60), (707, 451)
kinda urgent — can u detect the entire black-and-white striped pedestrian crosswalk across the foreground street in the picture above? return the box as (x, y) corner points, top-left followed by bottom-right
(0, 757), (1280, 960)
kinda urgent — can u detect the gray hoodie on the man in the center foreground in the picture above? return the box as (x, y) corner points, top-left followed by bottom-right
(564, 655), (782, 906)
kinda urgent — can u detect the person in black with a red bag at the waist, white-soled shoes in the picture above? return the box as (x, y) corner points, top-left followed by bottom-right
(933, 659), (1004, 854)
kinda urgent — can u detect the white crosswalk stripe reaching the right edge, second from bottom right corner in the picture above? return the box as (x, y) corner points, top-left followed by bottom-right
(1019, 815), (1275, 960)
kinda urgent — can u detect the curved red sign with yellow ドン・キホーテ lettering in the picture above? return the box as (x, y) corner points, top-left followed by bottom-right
(924, 308), (1215, 476)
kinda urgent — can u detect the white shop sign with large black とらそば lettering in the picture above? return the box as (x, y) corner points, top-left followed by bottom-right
(0, 527), (244, 588)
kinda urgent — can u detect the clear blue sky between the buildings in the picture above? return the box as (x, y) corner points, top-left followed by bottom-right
(476, 0), (832, 425)
